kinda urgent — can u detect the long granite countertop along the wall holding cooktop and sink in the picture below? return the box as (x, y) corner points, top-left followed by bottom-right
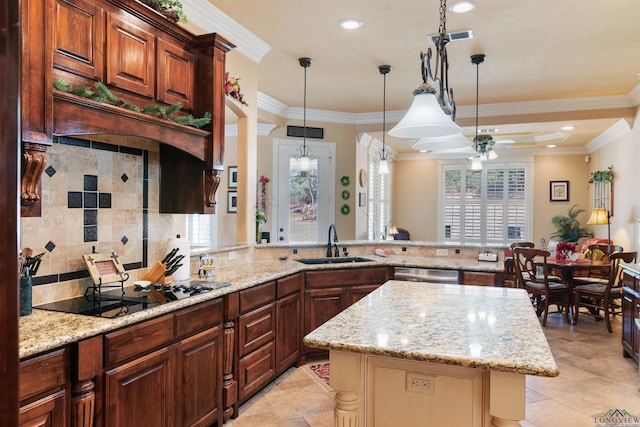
(19, 256), (504, 359)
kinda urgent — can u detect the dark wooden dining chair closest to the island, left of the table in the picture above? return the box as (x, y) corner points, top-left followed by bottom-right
(513, 248), (571, 326)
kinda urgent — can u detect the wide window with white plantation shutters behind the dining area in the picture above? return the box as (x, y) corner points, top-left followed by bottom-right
(439, 163), (533, 245)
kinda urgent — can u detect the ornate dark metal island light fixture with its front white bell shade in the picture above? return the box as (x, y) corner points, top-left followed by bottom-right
(389, 0), (462, 138)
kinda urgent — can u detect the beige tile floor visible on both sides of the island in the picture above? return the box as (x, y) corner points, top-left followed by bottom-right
(225, 314), (640, 427)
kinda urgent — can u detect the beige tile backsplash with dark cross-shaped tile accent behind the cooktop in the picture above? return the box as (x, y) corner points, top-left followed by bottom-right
(20, 135), (186, 305)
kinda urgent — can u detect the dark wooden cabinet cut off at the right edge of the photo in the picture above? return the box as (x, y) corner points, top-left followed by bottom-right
(622, 267), (640, 362)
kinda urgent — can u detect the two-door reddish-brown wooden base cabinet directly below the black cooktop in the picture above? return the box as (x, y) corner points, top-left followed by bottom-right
(104, 299), (223, 426)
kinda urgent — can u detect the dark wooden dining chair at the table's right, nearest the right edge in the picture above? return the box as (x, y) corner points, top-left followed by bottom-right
(573, 252), (638, 333)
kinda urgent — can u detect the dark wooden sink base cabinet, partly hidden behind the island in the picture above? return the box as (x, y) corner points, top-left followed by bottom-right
(304, 267), (391, 356)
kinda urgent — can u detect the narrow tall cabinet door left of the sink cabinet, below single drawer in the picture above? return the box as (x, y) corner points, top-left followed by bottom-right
(276, 292), (302, 373)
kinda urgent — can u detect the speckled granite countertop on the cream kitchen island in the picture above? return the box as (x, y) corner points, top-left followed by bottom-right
(304, 280), (559, 377)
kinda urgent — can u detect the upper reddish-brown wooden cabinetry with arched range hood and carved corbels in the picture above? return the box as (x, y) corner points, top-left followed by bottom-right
(21, 0), (235, 216)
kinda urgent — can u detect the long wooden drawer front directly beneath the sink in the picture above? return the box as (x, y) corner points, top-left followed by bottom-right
(305, 267), (389, 288)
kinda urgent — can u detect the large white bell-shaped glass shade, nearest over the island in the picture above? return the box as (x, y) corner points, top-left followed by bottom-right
(389, 92), (462, 138)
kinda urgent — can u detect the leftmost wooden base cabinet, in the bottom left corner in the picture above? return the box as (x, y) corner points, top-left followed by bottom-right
(19, 349), (69, 427)
